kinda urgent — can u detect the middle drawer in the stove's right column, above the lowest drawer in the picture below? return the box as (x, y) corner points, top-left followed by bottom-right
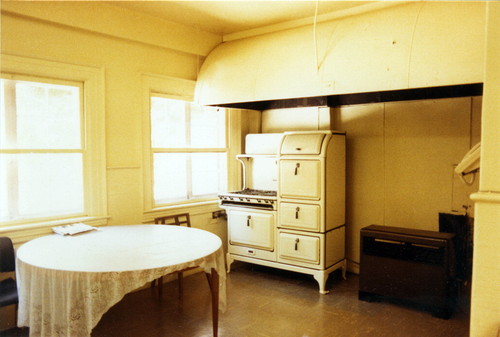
(279, 202), (321, 232)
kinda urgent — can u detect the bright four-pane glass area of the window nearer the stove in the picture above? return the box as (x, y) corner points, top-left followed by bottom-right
(150, 94), (227, 207)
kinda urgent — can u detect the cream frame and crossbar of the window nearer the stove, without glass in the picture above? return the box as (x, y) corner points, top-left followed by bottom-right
(142, 74), (230, 213)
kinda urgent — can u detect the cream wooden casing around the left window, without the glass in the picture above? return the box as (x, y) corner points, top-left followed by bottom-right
(0, 54), (108, 232)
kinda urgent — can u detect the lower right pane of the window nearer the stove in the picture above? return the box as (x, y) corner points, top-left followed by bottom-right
(191, 153), (226, 197)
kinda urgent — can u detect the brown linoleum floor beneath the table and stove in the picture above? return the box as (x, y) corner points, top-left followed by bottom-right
(0, 262), (469, 337)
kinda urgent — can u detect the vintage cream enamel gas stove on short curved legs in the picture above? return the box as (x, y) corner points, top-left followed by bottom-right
(219, 131), (346, 294)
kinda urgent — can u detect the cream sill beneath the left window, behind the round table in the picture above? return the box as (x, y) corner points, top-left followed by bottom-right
(0, 216), (108, 245)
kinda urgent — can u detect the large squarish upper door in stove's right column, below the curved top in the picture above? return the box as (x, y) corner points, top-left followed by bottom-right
(279, 159), (321, 200)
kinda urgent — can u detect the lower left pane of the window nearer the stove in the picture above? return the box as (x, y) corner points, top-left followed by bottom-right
(153, 153), (188, 204)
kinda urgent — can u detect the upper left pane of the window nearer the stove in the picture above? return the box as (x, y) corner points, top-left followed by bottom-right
(151, 97), (188, 148)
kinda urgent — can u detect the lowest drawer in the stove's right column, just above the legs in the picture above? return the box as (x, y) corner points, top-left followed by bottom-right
(278, 232), (321, 265)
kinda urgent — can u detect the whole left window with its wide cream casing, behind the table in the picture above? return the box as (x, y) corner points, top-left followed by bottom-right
(0, 55), (107, 226)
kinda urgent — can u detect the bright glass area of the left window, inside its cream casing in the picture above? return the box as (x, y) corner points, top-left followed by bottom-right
(0, 78), (84, 222)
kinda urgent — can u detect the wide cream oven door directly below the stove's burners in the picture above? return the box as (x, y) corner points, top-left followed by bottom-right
(227, 209), (276, 251)
